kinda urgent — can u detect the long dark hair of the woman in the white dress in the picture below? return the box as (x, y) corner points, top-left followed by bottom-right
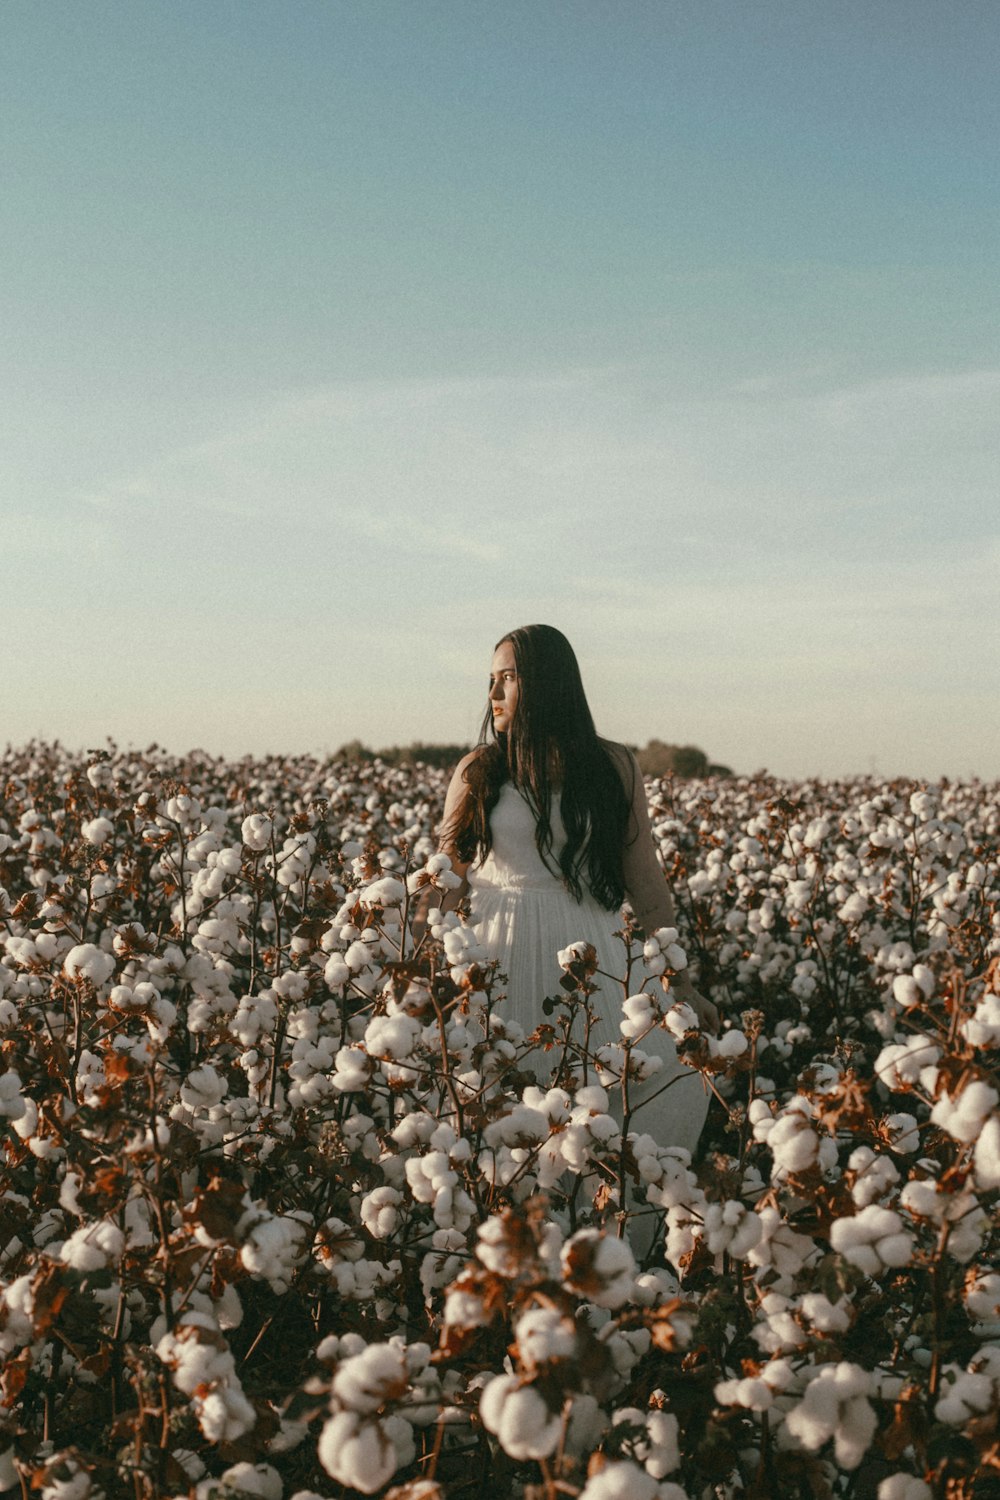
(447, 626), (630, 911)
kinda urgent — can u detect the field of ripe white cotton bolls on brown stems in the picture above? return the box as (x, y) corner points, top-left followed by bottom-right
(0, 744), (1000, 1500)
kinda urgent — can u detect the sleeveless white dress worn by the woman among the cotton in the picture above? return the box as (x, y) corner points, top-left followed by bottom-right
(468, 782), (708, 1152)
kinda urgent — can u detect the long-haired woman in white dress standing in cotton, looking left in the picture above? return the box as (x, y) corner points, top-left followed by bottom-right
(441, 626), (718, 1149)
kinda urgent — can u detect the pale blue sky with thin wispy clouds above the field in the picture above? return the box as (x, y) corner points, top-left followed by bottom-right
(0, 0), (1000, 779)
